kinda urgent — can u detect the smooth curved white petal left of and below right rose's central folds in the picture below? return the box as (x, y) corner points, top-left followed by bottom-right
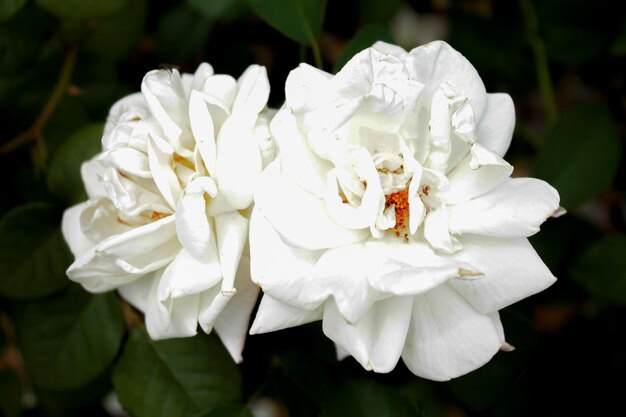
(254, 161), (369, 250)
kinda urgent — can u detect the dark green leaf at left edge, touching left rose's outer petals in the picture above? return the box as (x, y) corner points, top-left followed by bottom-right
(0, 203), (72, 299)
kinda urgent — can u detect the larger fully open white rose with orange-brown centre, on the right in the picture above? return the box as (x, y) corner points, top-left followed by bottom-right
(250, 42), (559, 380)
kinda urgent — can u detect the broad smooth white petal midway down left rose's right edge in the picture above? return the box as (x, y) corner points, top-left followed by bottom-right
(212, 114), (262, 211)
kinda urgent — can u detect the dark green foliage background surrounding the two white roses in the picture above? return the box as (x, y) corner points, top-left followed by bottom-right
(0, 0), (626, 417)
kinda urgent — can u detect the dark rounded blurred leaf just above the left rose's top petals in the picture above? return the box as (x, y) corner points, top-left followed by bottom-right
(156, 6), (212, 64)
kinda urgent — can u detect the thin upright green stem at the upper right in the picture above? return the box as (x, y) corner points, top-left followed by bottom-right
(520, 0), (559, 124)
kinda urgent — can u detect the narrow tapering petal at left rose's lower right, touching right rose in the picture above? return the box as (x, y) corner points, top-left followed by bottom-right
(215, 211), (249, 291)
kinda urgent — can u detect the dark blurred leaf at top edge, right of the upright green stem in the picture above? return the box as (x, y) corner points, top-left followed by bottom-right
(534, 0), (618, 66)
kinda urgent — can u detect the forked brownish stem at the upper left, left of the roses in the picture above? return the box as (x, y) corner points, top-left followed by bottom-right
(0, 44), (78, 156)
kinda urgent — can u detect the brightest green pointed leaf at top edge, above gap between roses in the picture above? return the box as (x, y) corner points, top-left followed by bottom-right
(248, 0), (326, 45)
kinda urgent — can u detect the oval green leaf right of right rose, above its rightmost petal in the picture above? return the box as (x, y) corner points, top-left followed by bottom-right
(534, 105), (620, 209)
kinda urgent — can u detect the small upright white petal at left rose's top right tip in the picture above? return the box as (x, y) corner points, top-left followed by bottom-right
(232, 65), (270, 114)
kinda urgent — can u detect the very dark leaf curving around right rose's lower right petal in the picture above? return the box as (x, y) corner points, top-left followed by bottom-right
(447, 310), (537, 412)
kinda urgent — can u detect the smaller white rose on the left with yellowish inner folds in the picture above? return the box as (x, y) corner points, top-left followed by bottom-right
(62, 63), (273, 361)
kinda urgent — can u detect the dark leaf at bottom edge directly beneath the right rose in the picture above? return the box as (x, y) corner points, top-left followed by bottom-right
(322, 379), (418, 417)
